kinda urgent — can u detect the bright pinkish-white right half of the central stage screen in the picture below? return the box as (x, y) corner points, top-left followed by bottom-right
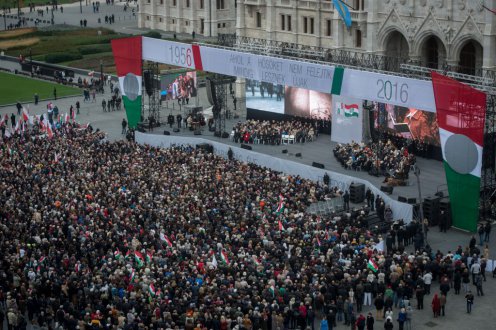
(284, 86), (332, 120)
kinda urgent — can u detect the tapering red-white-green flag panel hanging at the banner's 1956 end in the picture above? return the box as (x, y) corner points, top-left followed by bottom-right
(112, 36), (142, 128)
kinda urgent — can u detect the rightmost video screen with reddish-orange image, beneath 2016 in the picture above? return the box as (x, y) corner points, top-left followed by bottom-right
(374, 103), (441, 146)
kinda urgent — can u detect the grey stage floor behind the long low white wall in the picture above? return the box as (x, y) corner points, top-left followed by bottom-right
(142, 114), (447, 201)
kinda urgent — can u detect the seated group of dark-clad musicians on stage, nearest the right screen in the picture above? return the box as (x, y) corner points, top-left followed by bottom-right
(333, 140), (415, 180)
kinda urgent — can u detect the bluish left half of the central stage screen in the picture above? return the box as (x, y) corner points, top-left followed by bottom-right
(245, 79), (284, 114)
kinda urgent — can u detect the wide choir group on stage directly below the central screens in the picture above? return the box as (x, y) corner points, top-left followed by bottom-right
(232, 119), (318, 145)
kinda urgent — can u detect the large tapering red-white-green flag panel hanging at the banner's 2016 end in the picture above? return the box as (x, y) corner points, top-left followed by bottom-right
(431, 72), (486, 232)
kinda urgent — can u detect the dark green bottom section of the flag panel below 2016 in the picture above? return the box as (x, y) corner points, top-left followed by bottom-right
(444, 161), (480, 233)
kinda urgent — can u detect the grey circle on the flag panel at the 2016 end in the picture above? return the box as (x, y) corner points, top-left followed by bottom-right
(444, 134), (479, 174)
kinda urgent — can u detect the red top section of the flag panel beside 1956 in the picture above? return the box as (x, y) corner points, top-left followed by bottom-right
(111, 36), (142, 77)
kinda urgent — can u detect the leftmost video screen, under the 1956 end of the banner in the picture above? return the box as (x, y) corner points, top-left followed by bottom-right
(160, 71), (197, 101)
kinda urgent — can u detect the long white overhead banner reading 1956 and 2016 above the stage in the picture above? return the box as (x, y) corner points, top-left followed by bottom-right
(143, 37), (436, 112)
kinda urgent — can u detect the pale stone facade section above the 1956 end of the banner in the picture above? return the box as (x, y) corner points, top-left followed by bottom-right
(138, 0), (236, 37)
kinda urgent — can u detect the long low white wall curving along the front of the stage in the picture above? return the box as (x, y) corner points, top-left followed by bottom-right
(135, 132), (413, 223)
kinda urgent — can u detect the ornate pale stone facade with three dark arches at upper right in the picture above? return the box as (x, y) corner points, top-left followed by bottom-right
(236, 0), (496, 73)
